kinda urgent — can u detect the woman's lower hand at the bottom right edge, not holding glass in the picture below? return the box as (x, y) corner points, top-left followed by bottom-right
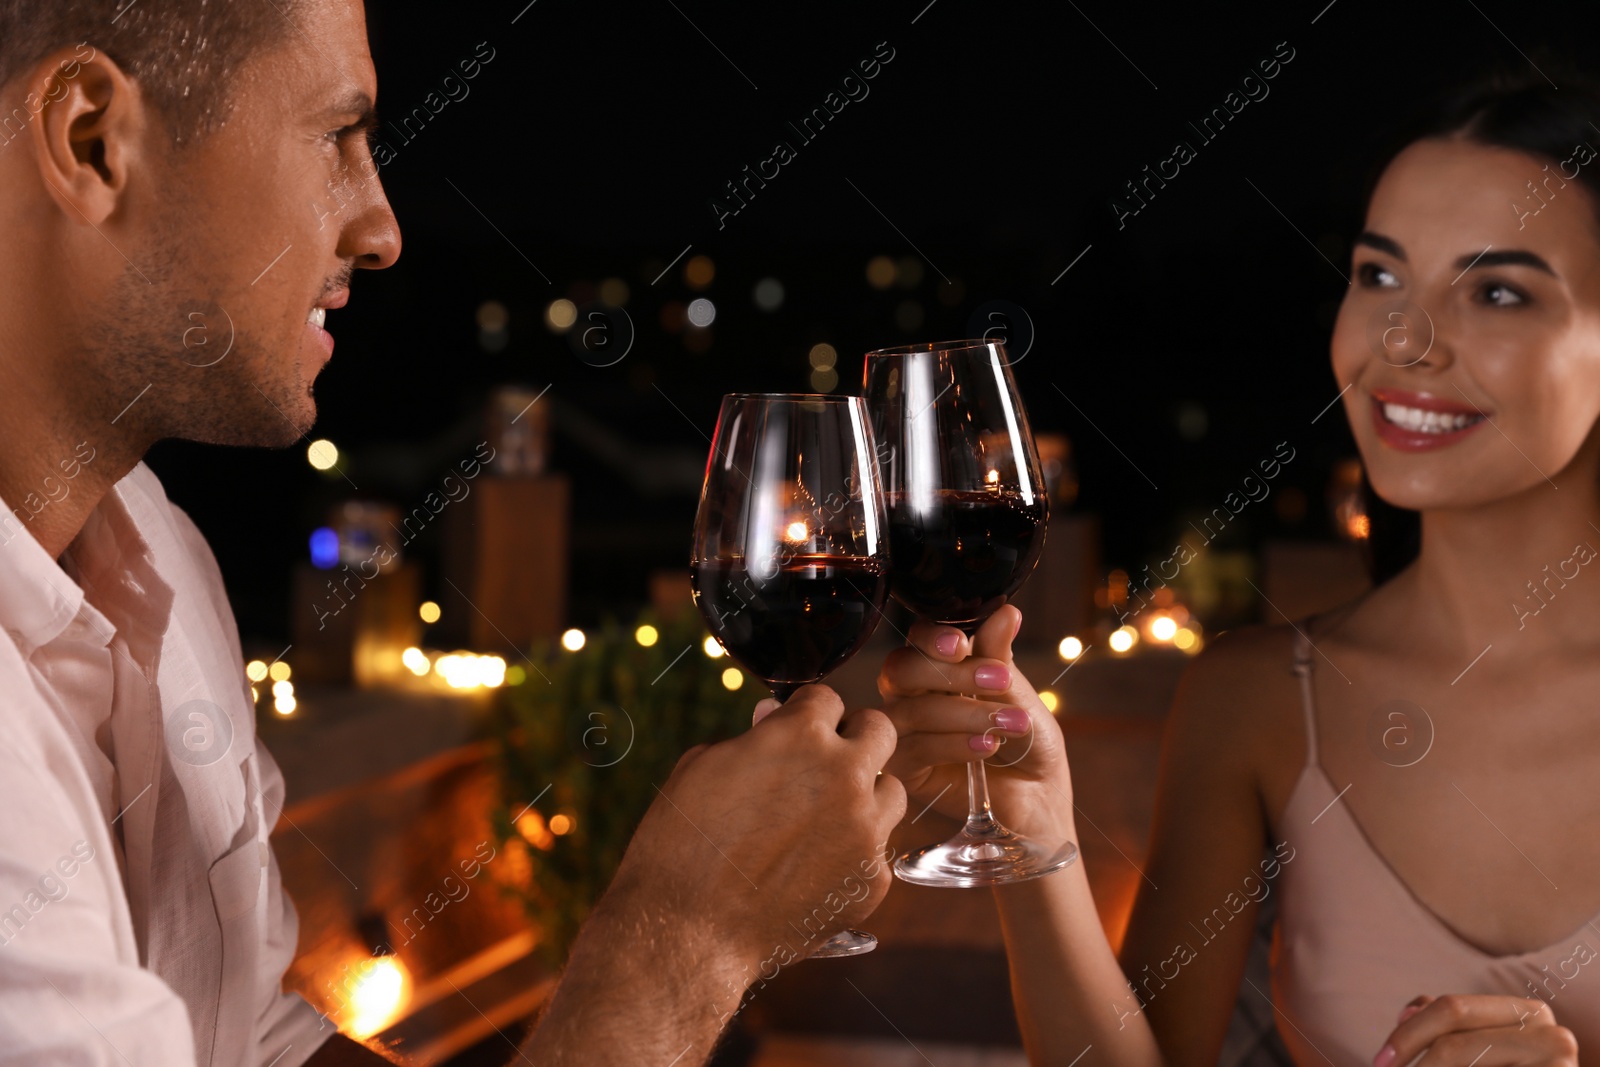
(1373, 993), (1578, 1067)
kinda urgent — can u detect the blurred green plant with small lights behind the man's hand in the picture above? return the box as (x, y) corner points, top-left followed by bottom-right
(493, 611), (752, 968)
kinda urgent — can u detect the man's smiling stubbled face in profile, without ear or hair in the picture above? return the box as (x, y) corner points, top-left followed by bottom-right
(91, 0), (400, 446)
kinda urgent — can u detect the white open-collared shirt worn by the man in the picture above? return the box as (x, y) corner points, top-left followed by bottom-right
(0, 464), (333, 1067)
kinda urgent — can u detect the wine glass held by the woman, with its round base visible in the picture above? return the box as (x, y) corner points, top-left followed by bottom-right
(866, 341), (1078, 886)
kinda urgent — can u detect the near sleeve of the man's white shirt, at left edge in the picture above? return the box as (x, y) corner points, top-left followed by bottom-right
(0, 703), (195, 1067)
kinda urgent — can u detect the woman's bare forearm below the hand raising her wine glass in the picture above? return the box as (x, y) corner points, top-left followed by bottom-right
(995, 833), (1162, 1067)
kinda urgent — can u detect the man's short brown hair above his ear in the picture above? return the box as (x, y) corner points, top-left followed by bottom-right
(0, 0), (301, 144)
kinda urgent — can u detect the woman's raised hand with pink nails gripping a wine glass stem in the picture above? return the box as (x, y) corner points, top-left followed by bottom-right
(878, 605), (1074, 835)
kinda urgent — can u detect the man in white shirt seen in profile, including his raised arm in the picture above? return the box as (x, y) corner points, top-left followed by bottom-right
(0, 0), (906, 1067)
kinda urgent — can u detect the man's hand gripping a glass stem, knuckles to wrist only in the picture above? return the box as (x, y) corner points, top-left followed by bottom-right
(613, 685), (906, 976)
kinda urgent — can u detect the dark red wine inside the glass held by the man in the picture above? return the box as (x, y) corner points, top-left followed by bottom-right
(690, 555), (888, 699)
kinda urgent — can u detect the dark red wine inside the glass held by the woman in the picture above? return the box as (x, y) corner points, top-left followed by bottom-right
(888, 490), (1050, 629)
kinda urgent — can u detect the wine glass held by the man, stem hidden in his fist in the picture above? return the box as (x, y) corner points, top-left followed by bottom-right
(691, 394), (888, 957)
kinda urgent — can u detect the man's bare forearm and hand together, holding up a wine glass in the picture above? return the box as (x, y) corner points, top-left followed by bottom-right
(523, 685), (906, 1067)
